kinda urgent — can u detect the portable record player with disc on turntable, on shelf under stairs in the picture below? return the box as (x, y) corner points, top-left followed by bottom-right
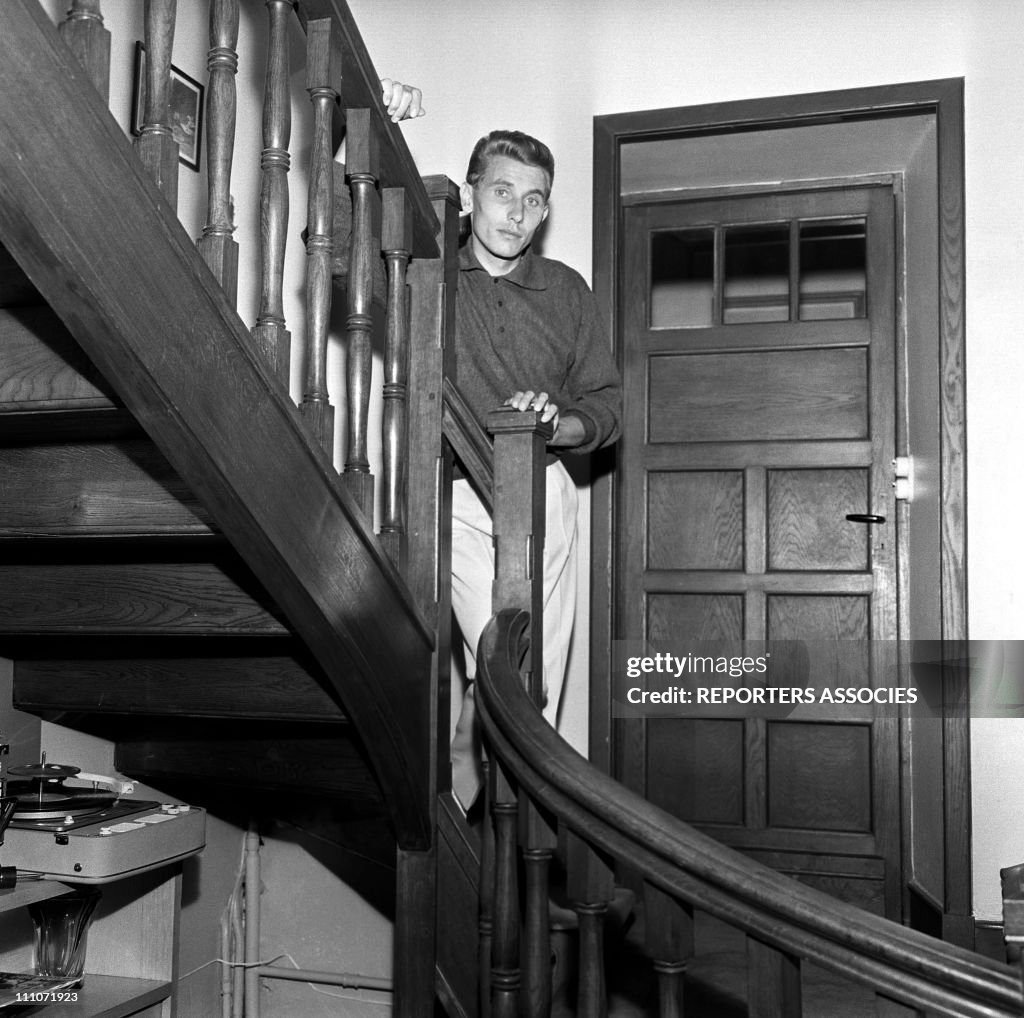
(0, 756), (206, 884)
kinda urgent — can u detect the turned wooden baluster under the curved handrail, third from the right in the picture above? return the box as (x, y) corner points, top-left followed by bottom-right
(566, 832), (614, 1018)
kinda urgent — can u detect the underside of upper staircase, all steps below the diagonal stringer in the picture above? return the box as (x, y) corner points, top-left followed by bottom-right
(0, 266), (382, 808)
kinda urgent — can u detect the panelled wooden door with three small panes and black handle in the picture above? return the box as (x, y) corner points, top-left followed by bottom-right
(615, 185), (901, 918)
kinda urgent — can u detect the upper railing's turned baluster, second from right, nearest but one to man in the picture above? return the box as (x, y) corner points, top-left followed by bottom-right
(344, 110), (381, 519)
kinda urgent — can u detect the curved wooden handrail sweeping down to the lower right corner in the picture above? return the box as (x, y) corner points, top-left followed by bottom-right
(477, 610), (1024, 1018)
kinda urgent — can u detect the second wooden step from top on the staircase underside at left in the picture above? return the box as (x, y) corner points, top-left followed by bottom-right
(0, 438), (213, 541)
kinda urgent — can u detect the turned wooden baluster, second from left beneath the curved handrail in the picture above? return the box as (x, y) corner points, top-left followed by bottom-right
(488, 760), (521, 1018)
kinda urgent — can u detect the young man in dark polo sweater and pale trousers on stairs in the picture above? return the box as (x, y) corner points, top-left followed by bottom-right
(452, 131), (622, 810)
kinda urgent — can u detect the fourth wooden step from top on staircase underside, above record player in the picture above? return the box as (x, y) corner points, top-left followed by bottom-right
(13, 640), (345, 724)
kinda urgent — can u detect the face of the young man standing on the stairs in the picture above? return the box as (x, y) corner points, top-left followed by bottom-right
(462, 156), (550, 275)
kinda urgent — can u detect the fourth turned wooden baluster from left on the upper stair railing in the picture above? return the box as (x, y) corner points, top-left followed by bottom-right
(252, 0), (293, 386)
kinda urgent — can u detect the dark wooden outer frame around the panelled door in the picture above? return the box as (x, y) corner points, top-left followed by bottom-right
(590, 78), (974, 946)
